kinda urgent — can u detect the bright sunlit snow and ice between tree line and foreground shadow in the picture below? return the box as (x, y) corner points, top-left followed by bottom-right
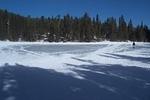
(0, 41), (150, 78)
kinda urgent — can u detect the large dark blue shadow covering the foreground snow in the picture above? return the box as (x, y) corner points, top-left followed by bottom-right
(0, 63), (150, 100)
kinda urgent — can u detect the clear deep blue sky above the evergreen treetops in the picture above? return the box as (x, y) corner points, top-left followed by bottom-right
(0, 0), (150, 26)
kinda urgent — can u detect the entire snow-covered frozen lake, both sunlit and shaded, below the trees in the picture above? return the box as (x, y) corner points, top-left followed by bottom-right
(0, 42), (150, 100)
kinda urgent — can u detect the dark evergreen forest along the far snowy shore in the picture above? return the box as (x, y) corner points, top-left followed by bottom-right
(0, 10), (150, 42)
